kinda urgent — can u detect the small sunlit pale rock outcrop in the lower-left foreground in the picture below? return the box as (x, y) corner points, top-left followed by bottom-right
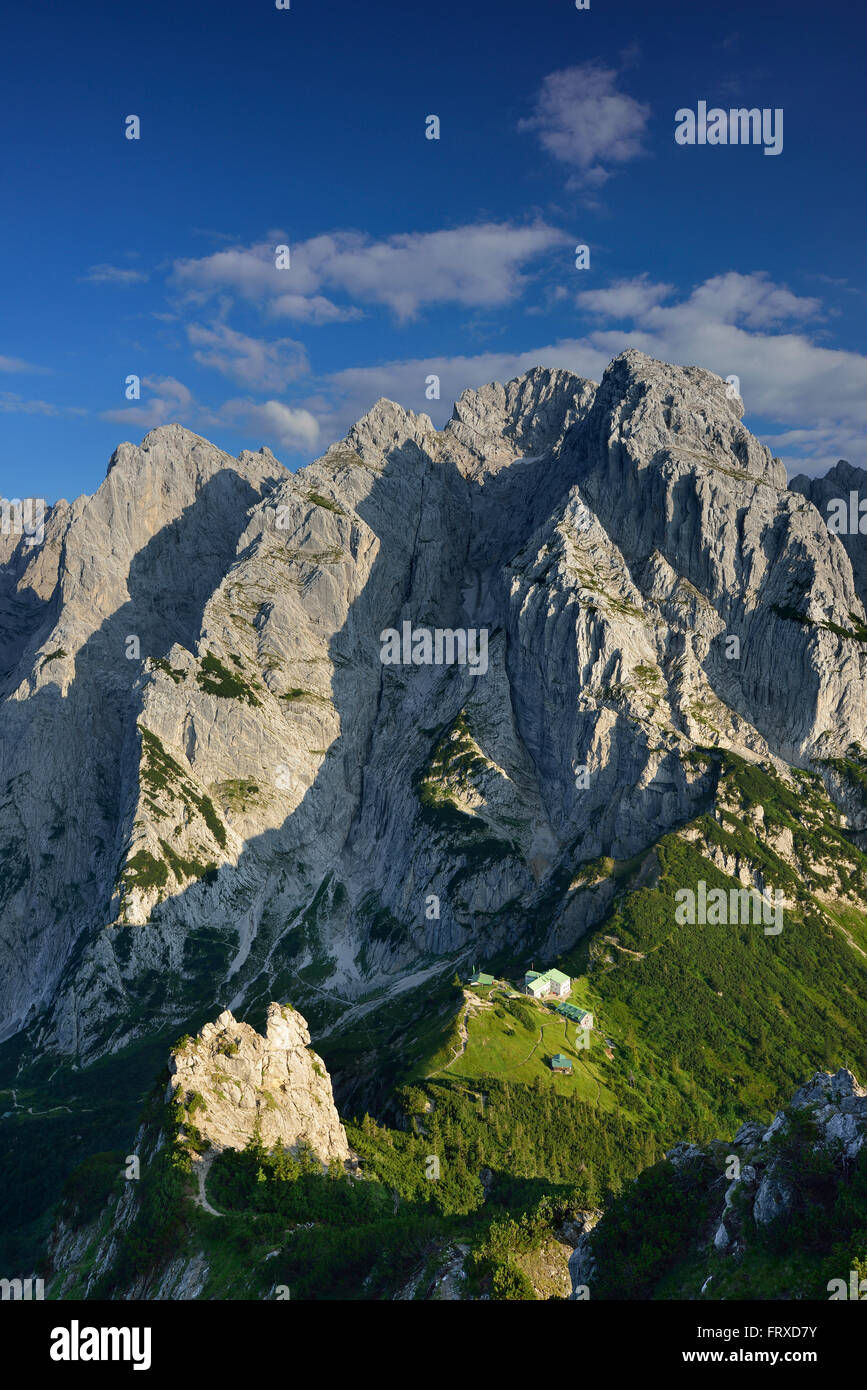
(170, 1004), (350, 1163)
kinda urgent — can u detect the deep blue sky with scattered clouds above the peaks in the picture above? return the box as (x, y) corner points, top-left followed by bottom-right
(0, 0), (867, 500)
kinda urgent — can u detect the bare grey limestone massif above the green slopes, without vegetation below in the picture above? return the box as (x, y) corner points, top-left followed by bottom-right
(0, 350), (867, 1059)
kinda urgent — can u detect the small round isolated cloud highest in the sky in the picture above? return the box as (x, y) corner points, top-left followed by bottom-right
(518, 63), (650, 185)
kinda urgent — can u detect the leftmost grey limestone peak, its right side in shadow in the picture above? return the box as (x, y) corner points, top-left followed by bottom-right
(0, 425), (285, 1051)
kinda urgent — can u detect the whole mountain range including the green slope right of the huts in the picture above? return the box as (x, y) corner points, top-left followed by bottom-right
(0, 350), (867, 1289)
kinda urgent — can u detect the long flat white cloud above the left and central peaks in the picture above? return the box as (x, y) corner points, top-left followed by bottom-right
(175, 222), (570, 322)
